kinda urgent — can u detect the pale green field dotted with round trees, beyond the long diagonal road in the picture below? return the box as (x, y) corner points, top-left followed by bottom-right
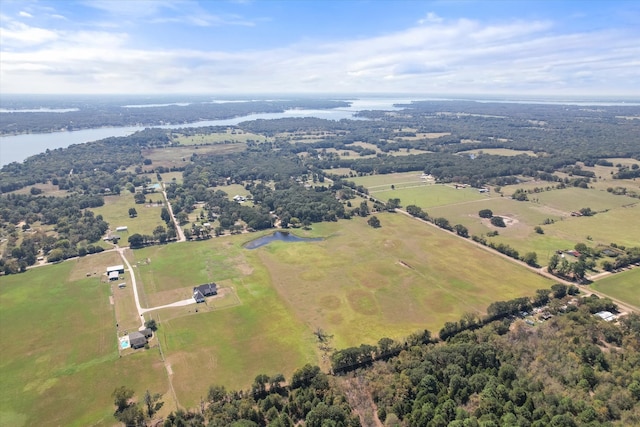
(422, 188), (640, 265)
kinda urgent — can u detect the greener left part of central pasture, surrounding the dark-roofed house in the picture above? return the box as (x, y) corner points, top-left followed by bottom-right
(134, 234), (318, 406)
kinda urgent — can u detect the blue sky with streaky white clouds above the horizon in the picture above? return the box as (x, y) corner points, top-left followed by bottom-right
(0, 0), (640, 96)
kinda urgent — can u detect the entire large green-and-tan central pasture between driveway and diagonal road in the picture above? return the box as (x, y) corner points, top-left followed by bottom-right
(121, 214), (552, 406)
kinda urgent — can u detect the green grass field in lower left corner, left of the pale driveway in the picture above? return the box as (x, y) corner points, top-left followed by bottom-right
(0, 254), (170, 426)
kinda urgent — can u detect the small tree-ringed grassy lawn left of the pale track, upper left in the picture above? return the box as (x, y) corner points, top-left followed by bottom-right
(92, 191), (165, 237)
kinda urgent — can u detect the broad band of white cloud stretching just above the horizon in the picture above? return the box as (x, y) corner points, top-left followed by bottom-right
(0, 12), (640, 94)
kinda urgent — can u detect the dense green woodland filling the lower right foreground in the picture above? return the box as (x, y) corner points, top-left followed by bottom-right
(114, 300), (640, 427)
